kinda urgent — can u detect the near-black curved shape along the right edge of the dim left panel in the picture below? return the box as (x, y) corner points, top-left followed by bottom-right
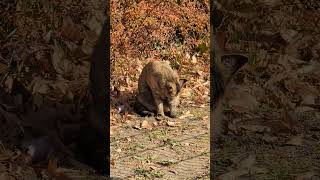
(90, 1), (110, 177)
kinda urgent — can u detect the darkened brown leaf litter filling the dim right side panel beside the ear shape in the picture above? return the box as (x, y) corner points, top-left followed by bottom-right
(212, 0), (320, 179)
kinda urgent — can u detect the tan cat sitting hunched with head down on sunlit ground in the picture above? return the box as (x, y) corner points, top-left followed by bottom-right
(135, 61), (187, 118)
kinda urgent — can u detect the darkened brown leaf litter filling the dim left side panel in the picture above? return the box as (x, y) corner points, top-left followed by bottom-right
(0, 0), (105, 179)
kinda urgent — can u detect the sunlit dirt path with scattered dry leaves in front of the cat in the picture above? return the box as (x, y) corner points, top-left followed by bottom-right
(110, 106), (210, 179)
